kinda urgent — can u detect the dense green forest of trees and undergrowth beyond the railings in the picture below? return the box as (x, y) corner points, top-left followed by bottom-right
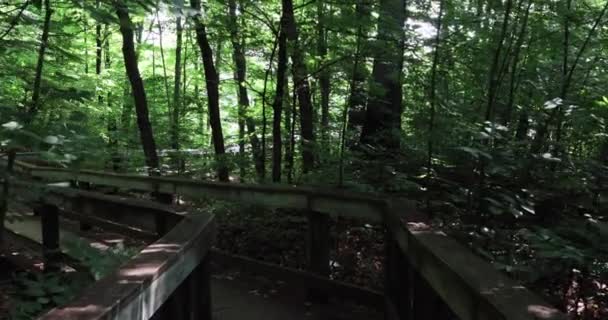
(0, 0), (608, 319)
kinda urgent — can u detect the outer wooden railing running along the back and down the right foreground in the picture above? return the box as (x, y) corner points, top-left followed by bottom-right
(3, 158), (566, 320)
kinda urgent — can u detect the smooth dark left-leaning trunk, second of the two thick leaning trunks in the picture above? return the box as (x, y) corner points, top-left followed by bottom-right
(190, 0), (229, 182)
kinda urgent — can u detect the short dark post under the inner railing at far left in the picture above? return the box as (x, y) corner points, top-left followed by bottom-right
(34, 204), (61, 272)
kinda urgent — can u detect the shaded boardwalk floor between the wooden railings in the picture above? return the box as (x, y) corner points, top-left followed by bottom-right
(6, 211), (383, 320)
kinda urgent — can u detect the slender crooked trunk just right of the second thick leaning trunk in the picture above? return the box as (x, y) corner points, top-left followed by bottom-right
(228, 0), (264, 180)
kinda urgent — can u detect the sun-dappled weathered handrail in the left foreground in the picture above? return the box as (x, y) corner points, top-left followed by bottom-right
(38, 211), (217, 320)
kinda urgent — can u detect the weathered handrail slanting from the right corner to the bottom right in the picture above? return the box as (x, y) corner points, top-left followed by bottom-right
(385, 208), (566, 320)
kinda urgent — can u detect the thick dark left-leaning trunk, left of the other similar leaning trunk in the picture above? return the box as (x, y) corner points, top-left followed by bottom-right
(115, 1), (160, 176)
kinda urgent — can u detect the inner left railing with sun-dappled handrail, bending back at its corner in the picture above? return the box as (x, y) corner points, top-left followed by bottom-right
(11, 182), (217, 320)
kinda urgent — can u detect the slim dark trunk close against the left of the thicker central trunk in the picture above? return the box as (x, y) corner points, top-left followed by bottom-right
(272, 13), (288, 182)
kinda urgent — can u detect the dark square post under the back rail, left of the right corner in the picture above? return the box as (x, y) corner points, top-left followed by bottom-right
(307, 211), (330, 303)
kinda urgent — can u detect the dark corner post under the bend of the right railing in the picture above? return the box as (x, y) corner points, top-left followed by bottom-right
(384, 229), (417, 320)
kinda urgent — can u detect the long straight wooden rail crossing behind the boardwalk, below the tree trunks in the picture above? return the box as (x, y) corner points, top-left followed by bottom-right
(21, 167), (384, 222)
